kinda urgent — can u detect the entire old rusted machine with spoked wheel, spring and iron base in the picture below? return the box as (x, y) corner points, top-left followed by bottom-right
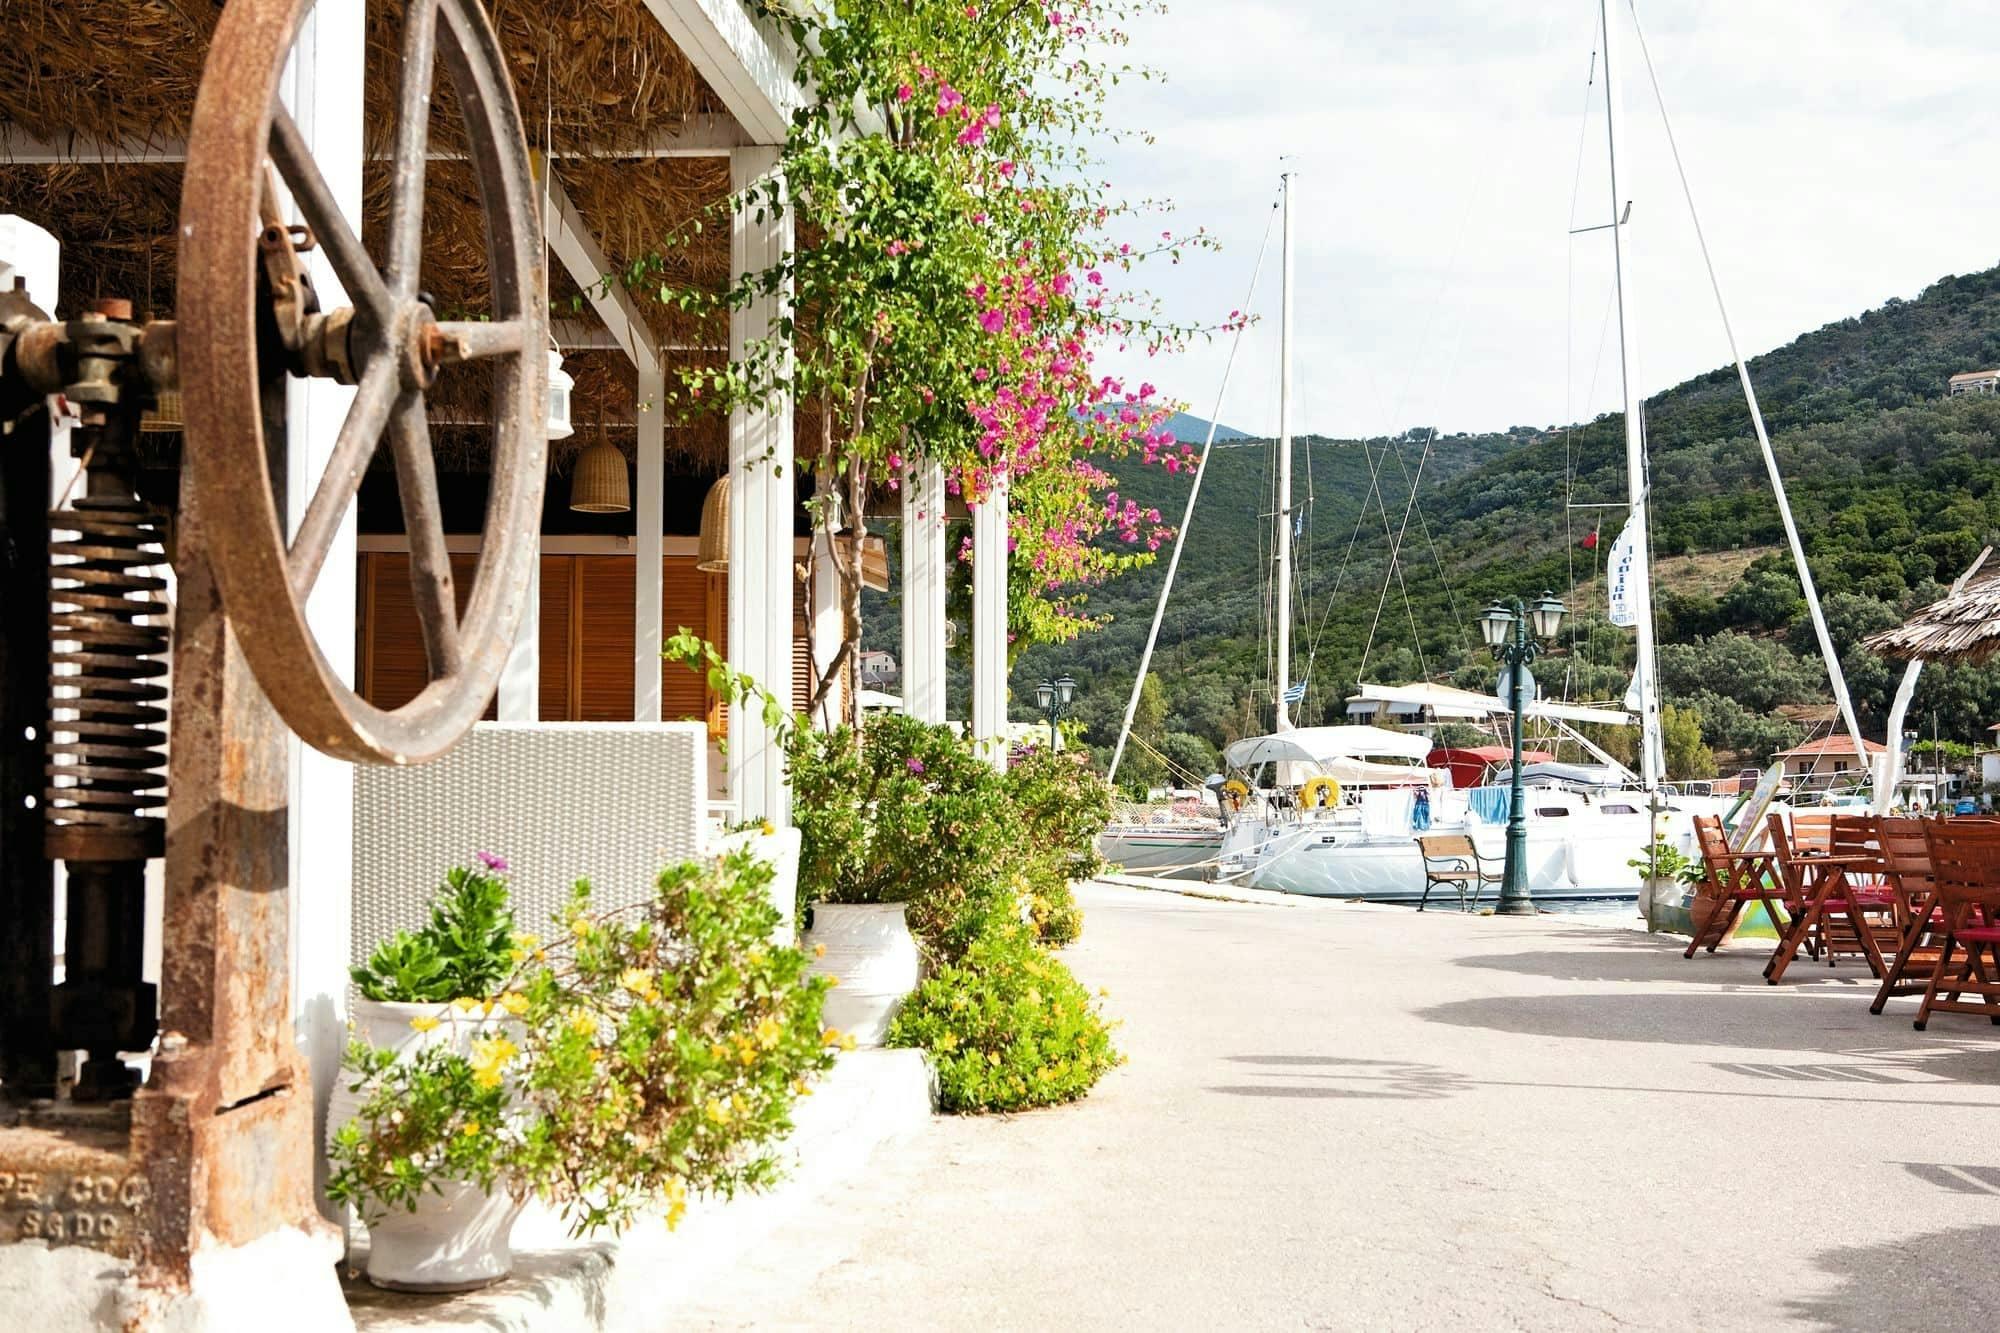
(0, 0), (548, 1287)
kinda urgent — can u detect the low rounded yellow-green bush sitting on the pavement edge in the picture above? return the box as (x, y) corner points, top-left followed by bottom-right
(888, 929), (1122, 1111)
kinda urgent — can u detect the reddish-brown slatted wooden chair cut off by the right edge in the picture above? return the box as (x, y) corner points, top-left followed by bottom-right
(1916, 819), (2000, 1033)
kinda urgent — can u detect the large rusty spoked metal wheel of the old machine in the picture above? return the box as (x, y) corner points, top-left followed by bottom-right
(176, 0), (548, 763)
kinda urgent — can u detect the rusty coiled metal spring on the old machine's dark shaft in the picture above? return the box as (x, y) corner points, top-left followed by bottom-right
(44, 494), (168, 837)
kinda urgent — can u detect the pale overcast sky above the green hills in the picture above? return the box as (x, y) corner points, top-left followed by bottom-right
(1108, 0), (2000, 436)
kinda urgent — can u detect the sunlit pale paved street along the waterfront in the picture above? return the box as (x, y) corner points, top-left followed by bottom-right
(698, 885), (2000, 1329)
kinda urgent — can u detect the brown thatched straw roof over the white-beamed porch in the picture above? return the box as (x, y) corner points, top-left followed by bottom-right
(0, 0), (812, 466)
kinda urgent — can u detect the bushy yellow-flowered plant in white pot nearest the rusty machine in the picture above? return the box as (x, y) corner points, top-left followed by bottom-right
(328, 851), (844, 1291)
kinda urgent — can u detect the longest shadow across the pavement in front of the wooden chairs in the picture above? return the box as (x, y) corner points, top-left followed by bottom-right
(1416, 987), (2000, 1087)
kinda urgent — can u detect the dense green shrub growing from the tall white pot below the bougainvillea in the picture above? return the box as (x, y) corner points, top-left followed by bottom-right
(788, 715), (1022, 959)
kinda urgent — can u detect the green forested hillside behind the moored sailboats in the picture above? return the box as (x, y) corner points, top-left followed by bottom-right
(1014, 270), (2000, 769)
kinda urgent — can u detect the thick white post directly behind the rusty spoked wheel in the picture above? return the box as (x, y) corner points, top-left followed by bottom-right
(284, 0), (368, 1200)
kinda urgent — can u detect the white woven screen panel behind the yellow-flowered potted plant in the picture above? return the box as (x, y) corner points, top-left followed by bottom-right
(354, 723), (708, 963)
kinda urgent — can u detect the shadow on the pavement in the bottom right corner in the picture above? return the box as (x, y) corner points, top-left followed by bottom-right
(1784, 1227), (2000, 1329)
